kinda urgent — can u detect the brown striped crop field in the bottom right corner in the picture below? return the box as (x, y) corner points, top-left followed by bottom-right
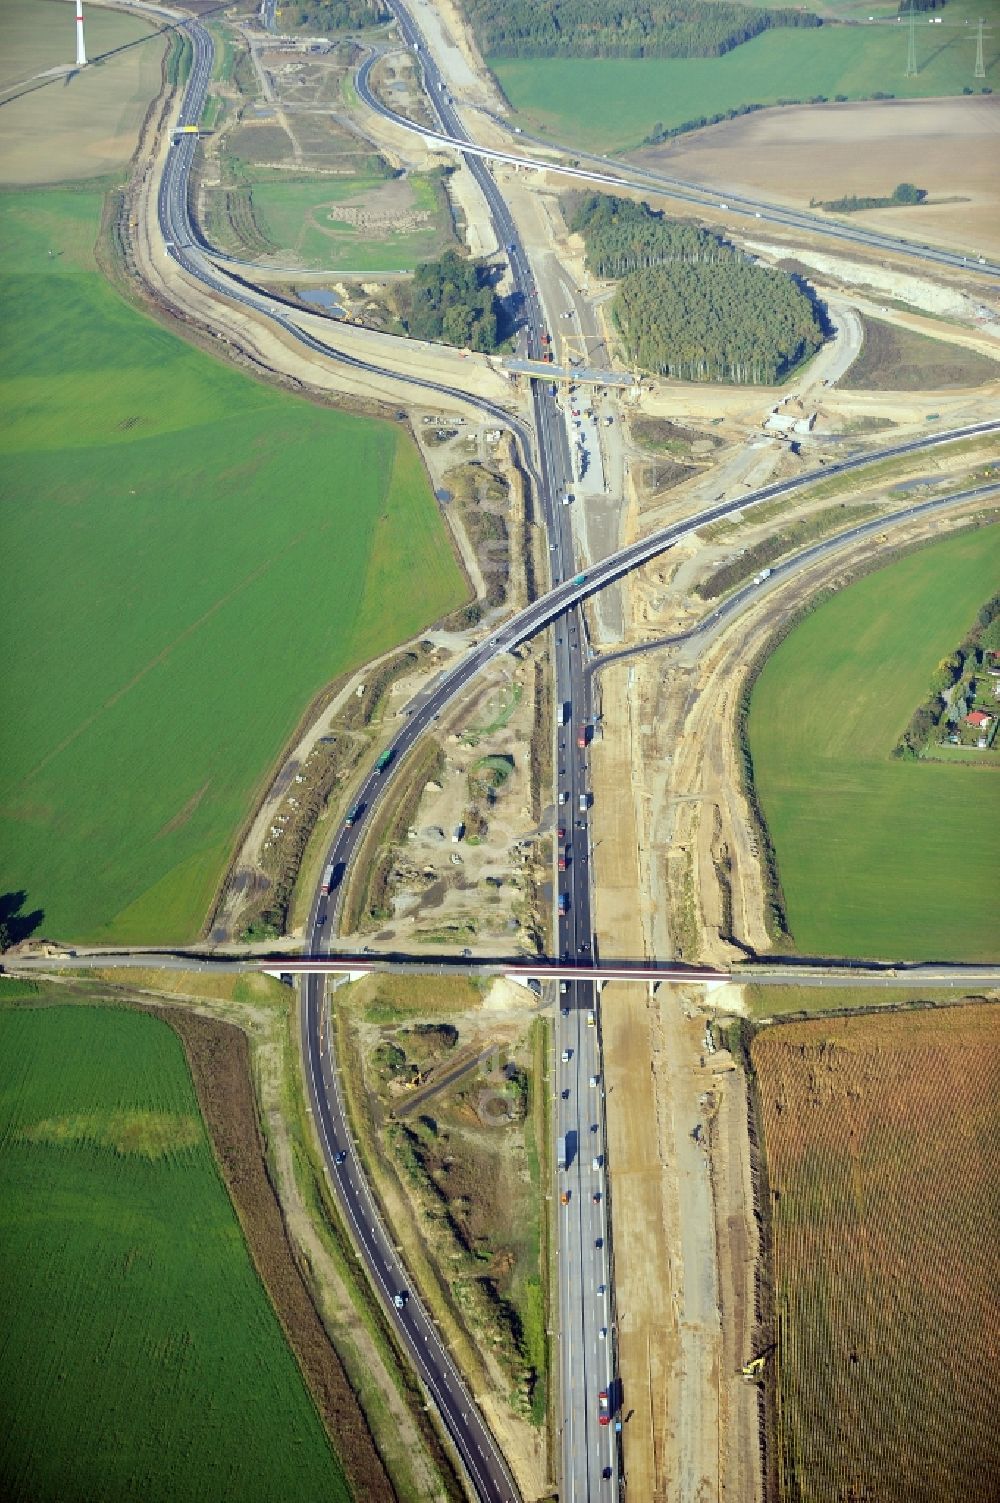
(752, 1006), (1000, 1503)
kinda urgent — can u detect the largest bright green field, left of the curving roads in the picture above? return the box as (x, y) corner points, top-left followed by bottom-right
(0, 191), (465, 942)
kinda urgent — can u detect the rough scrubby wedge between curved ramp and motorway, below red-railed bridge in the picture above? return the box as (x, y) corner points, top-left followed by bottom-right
(334, 975), (547, 1498)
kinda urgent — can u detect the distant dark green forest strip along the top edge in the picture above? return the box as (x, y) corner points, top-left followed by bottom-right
(465, 0), (823, 57)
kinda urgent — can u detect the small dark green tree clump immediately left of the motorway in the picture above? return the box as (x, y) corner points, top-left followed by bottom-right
(400, 251), (501, 353)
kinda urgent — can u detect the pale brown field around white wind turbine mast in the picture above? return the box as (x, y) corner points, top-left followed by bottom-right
(0, 0), (165, 185)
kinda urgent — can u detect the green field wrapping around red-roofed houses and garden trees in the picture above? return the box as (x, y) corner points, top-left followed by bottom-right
(750, 526), (1000, 960)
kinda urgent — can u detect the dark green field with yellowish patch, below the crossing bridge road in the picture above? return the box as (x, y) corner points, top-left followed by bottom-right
(0, 1007), (349, 1503)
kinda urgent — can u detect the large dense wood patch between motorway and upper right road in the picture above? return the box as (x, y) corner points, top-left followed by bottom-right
(573, 194), (823, 385)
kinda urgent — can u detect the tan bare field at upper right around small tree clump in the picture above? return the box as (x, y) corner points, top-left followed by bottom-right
(629, 96), (1000, 253)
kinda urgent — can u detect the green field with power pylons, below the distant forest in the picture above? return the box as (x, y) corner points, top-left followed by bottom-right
(490, 26), (1000, 152)
